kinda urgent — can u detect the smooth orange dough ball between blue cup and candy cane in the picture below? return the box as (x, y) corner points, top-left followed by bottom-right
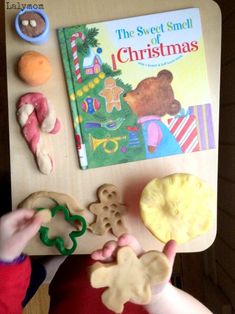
(18, 51), (52, 86)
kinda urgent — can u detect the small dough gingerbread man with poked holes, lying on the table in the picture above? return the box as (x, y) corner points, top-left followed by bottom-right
(89, 184), (127, 237)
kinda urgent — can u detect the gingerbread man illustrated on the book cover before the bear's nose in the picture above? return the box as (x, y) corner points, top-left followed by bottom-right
(99, 77), (124, 113)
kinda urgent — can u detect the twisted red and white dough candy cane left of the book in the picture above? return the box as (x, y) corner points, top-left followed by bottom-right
(16, 93), (60, 174)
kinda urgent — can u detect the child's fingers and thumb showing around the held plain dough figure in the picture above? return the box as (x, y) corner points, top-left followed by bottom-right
(91, 234), (176, 294)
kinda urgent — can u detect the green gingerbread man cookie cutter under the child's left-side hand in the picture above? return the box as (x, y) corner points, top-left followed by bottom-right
(37, 205), (87, 255)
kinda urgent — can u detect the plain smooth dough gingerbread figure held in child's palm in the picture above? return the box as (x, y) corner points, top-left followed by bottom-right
(90, 247), (170, 313)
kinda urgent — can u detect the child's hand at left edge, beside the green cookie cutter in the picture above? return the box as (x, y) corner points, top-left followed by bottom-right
(0, 209), (42, 262)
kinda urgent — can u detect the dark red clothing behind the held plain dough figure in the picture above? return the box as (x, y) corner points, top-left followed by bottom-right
(49, 255), (148, 314)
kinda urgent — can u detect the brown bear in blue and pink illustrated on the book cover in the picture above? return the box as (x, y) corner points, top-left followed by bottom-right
(123, 70), (182, 158)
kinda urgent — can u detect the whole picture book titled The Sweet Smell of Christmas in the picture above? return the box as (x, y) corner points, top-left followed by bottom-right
(58, 8), (215, 169)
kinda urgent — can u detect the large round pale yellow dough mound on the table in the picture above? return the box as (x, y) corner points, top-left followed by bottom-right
(140, 173), (215, 243)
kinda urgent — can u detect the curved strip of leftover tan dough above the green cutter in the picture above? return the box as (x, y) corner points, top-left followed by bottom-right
(18, 191), (83, 215)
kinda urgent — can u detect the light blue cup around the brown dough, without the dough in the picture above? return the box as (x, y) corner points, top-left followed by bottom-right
(15, 9), (49, 45)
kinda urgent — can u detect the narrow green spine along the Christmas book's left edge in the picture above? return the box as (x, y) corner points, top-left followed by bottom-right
(57, 28), (88, 170)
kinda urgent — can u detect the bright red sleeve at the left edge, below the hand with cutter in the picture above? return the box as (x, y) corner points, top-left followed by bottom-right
(0, 257), (31, 314)
